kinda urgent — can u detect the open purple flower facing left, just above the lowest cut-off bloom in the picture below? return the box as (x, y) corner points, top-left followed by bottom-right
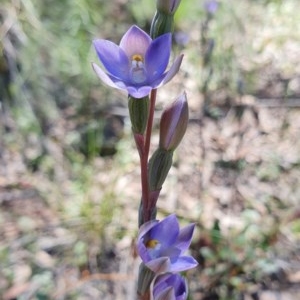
(137, 214), (198, 273)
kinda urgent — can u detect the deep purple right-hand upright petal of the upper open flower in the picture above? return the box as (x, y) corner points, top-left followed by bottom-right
(145, 33), (172, 82)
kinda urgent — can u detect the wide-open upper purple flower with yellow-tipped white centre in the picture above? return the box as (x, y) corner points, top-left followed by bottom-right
(92, 25), (183, 98)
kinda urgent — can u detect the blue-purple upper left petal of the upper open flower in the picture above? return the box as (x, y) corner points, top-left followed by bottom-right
(93, 40), (130, 81)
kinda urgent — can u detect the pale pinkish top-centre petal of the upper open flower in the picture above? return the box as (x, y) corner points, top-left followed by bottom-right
(120, 25), (152, 60)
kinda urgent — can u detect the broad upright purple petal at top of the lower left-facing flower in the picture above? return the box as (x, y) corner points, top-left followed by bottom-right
(151, 214), (179, 248)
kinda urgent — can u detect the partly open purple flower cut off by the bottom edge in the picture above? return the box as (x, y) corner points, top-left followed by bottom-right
(153, 273), (188, 300)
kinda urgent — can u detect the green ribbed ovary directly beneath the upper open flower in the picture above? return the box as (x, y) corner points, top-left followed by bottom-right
(128, 96), (149, 134)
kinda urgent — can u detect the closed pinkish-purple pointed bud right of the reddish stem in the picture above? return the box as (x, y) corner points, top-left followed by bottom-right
(159, 93), (189, 151)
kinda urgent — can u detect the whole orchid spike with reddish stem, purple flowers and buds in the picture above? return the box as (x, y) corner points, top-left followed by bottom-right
(93, 0), (198, 300)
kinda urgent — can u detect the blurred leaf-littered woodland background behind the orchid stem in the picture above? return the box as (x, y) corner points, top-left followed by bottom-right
(0, 0), (300, 300)
